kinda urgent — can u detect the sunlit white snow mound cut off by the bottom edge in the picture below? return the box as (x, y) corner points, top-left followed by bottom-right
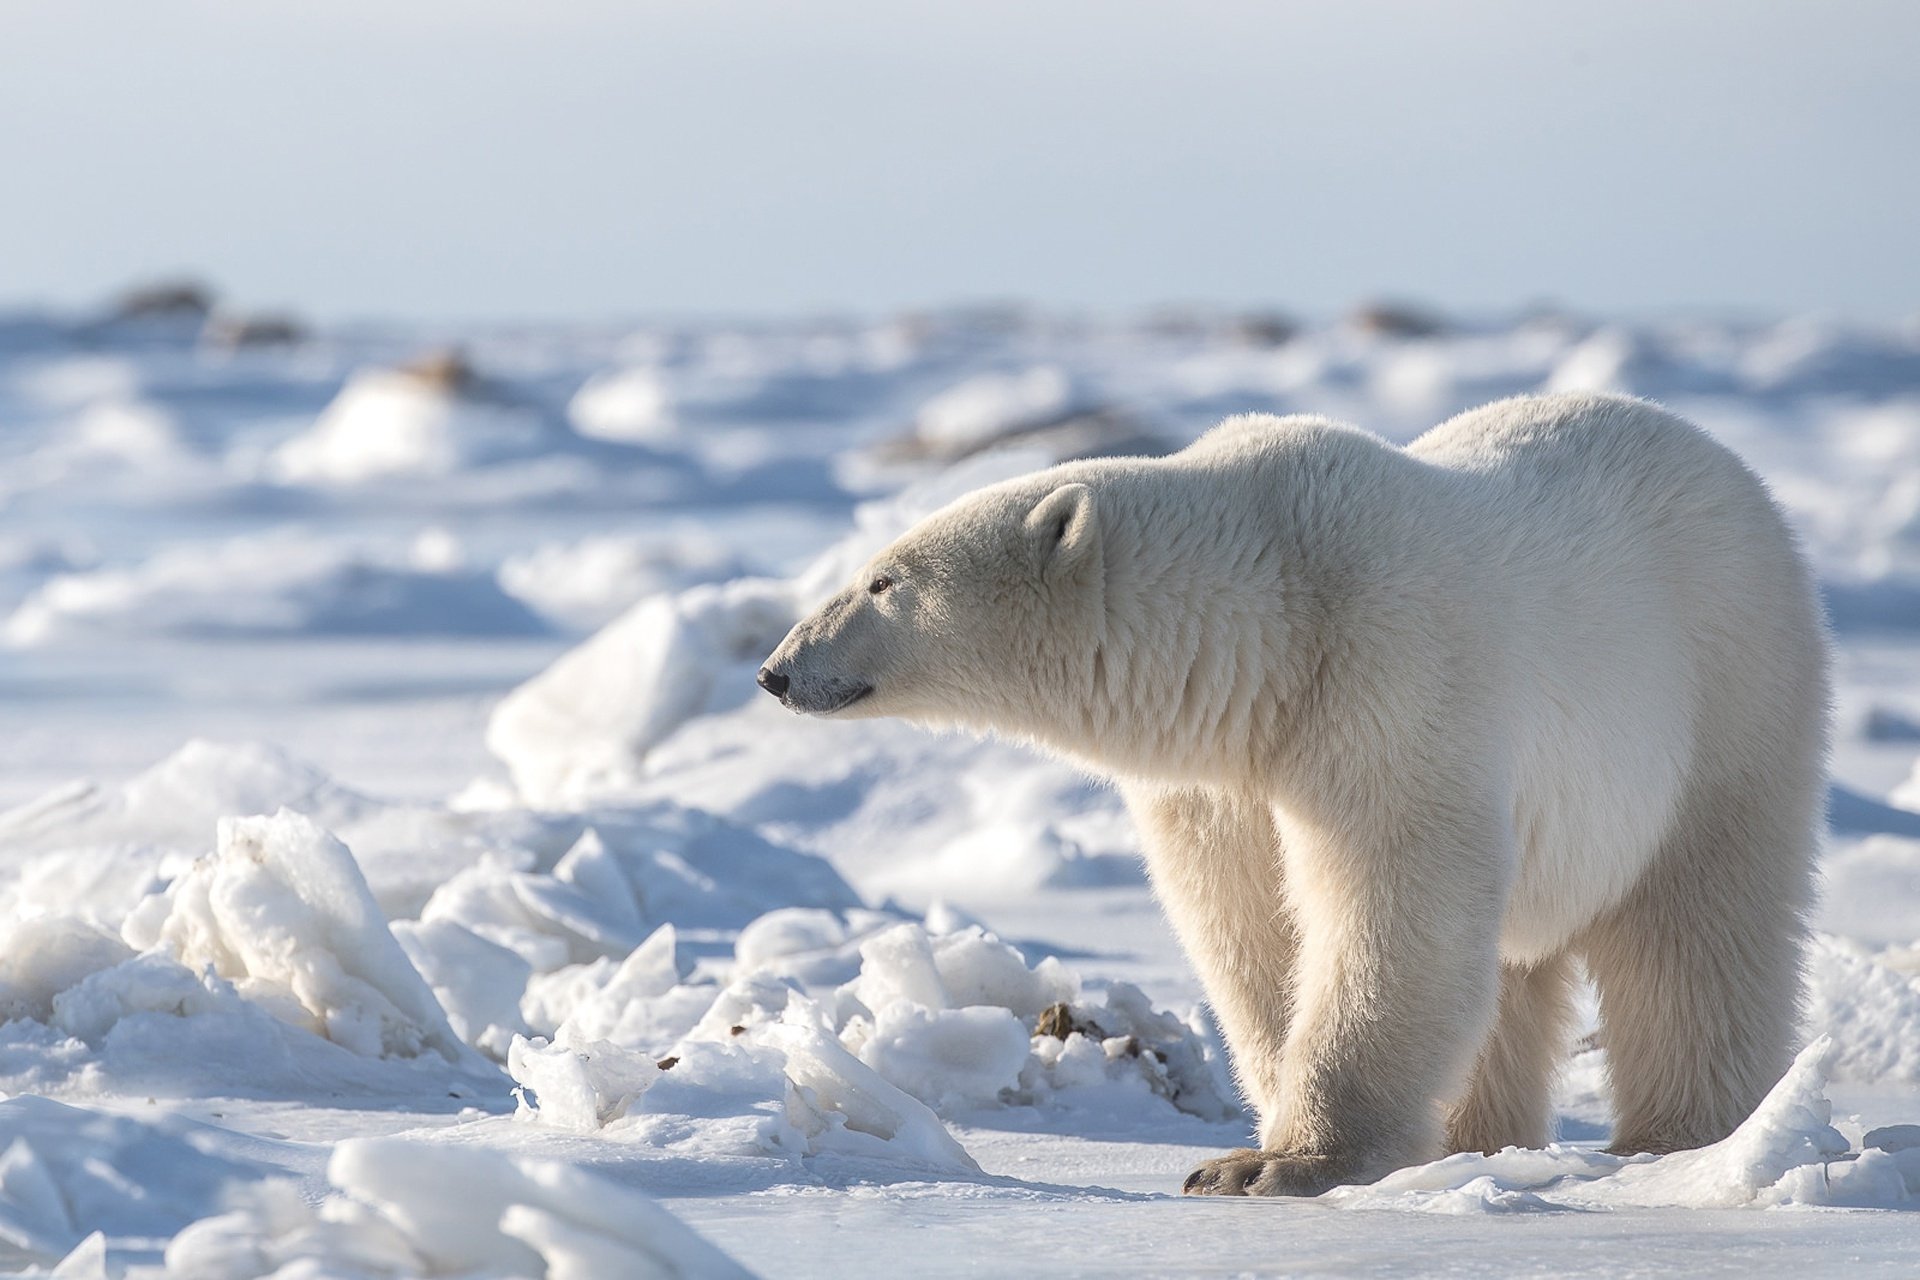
(167, 1138), (749, 1280)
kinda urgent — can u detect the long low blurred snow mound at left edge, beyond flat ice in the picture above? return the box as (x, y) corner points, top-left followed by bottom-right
(4, 533), (547, 647)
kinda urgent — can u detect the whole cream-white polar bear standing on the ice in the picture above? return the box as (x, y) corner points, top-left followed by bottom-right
(760, 395), (1828, 1196)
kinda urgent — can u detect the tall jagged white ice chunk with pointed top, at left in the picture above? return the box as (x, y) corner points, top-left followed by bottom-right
(116, 810), (465, 1063)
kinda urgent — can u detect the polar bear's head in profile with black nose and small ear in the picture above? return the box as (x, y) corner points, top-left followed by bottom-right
(760, 472), (1104, 731)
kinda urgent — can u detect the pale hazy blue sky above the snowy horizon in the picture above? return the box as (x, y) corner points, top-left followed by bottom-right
(0, 0), (1920, 319)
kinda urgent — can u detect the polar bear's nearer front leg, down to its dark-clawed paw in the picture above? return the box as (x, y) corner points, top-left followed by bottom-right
(1187, 804), (1509, 1196)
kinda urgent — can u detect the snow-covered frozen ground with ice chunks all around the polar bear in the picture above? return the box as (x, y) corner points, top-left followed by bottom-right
(0, 297), (1920, 1276)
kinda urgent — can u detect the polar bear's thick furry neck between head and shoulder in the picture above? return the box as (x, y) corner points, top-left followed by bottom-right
(1033, 430), (1443, 787)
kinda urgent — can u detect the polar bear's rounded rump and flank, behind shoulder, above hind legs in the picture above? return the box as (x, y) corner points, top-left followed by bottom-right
(1407, 395), (1828, 958)
